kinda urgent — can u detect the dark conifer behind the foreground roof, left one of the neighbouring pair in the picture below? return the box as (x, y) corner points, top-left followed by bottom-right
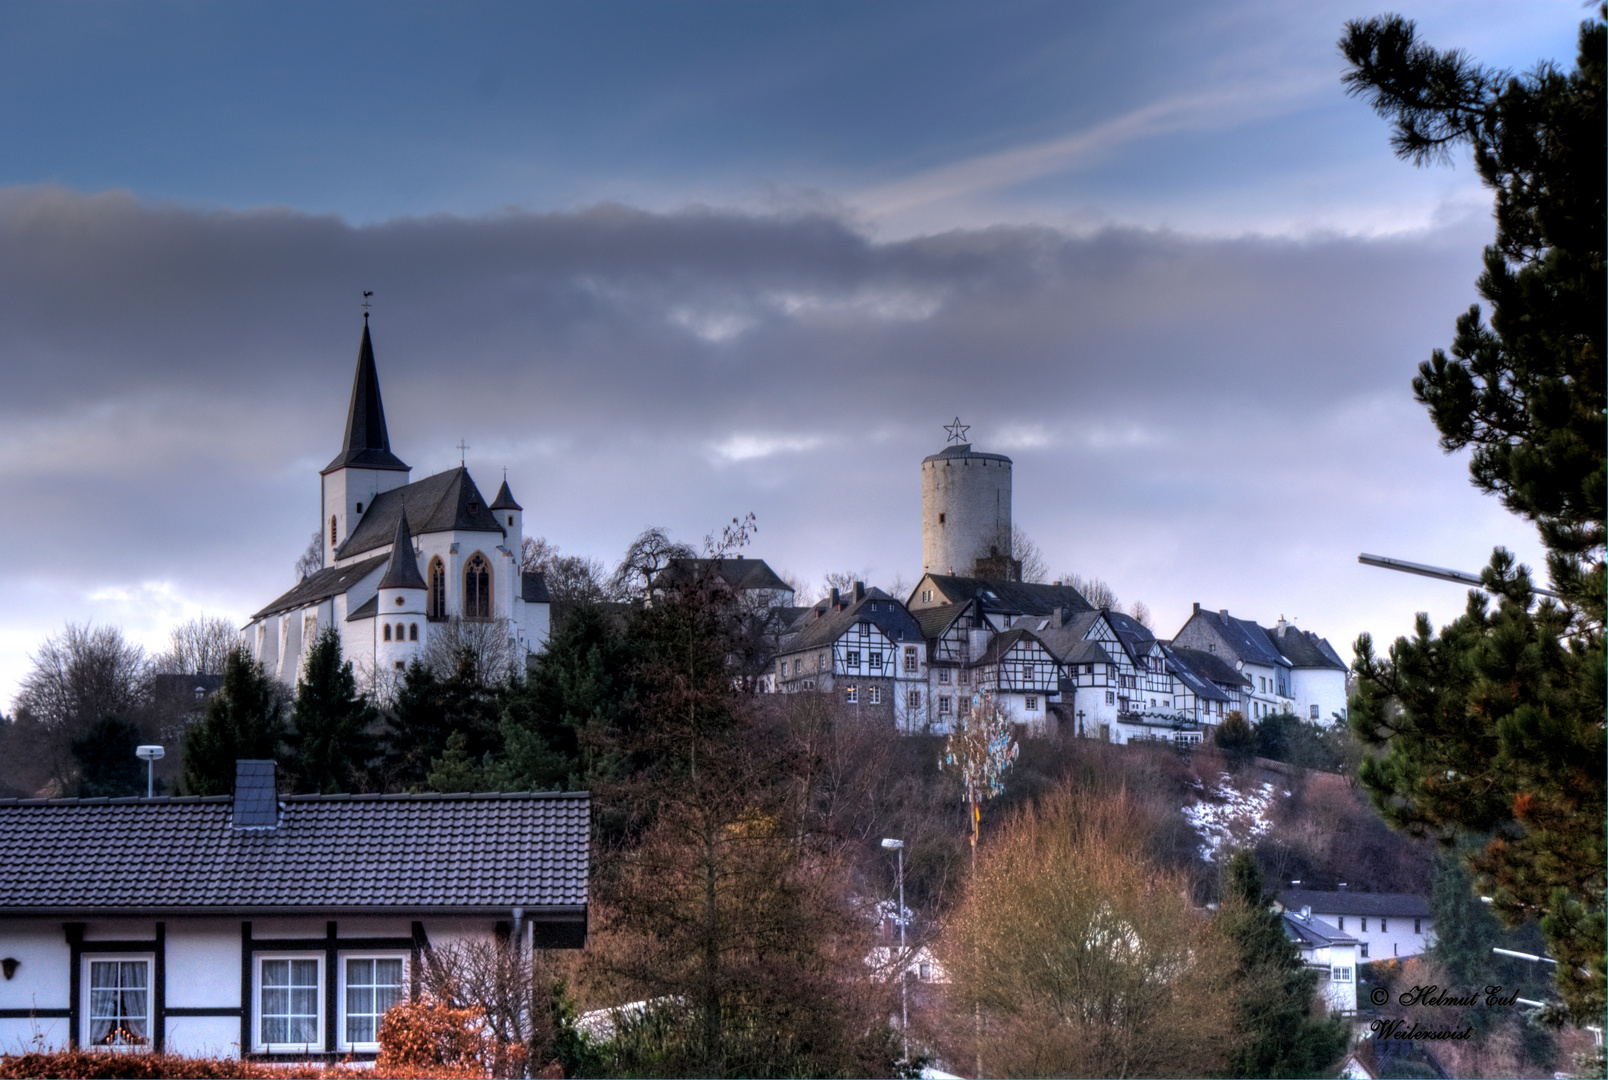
(182, 649), (285, 796)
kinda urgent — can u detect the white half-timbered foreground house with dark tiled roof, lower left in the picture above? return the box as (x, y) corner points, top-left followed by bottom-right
(0, 762), (590, 1059)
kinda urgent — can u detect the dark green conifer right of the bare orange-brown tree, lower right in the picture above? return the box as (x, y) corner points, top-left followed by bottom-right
(1219, 852), (1348, 1077)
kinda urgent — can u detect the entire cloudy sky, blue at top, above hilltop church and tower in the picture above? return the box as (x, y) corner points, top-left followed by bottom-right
(0, 0), (1589, 707)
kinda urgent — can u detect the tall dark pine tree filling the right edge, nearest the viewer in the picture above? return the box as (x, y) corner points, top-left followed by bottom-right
(1341, 16), (1608, 1022)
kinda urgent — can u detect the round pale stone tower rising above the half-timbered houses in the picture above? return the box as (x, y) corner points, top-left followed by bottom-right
(921, 442), (1010, 577)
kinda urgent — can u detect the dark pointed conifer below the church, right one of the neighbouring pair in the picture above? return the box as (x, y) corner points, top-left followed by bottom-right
(289, 627), (379, 794)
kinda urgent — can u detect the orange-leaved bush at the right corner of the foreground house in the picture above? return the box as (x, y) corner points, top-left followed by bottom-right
(375, 995), (526, 1077)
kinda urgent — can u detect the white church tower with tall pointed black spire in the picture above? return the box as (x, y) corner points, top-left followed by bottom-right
(318, 313), (408, 566)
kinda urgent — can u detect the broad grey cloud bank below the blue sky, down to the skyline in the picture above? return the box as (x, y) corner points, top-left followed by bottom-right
(0, 188), (1543, 698)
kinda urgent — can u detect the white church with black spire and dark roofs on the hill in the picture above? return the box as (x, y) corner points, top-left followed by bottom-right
(241, 321), (550, 686)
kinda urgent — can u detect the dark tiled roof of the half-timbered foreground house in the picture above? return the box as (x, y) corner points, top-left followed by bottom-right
(0, 792), (590, 916)
